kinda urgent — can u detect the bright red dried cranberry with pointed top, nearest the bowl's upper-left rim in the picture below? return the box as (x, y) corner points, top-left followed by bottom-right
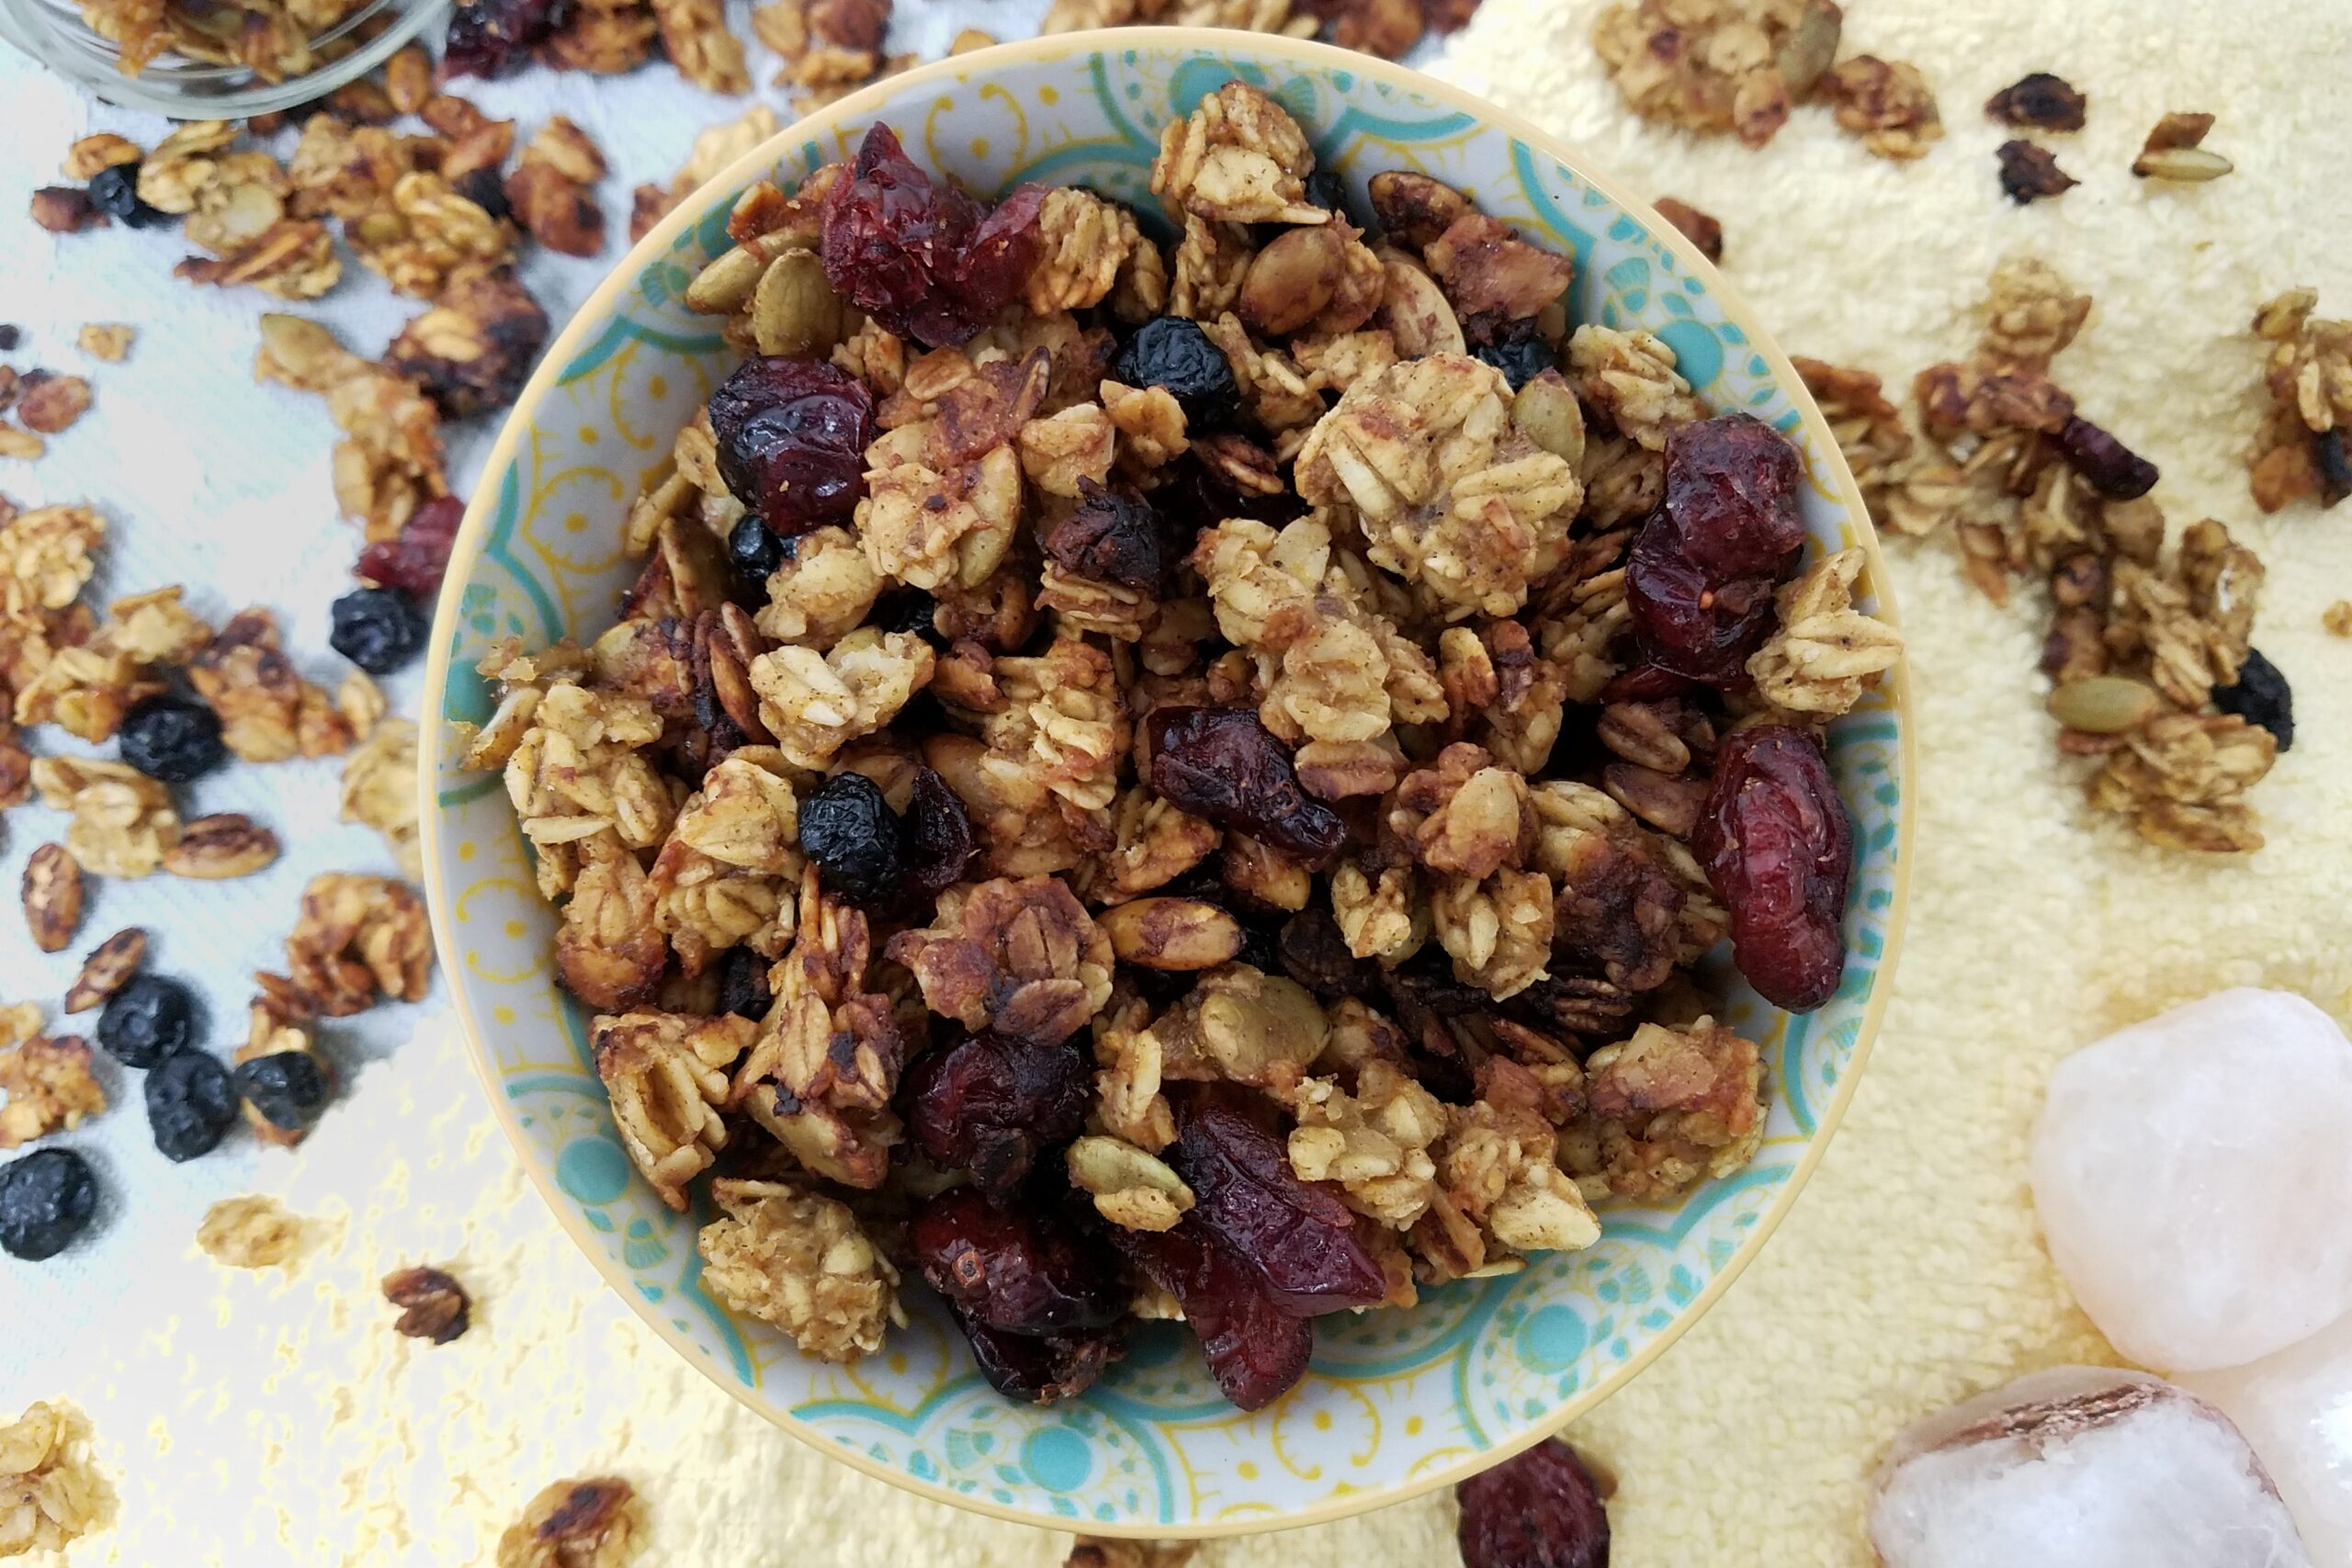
(820, 125), (1045, 348)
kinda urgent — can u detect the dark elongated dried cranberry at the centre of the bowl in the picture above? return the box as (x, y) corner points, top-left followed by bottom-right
(1150, 707), (1348, 867)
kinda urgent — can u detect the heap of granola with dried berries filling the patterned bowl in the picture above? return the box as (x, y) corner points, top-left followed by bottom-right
(463, 83), (1900, 1408)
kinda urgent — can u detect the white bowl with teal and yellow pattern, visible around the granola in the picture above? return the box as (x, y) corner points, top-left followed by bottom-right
(425, 30), (1905, 1535)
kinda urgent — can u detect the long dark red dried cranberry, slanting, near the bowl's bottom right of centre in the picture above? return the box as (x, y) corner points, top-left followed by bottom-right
(1167, 1086), (1387, 1316)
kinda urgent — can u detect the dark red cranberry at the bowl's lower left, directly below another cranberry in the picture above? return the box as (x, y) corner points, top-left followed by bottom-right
(908, 1187), (1126, 1336)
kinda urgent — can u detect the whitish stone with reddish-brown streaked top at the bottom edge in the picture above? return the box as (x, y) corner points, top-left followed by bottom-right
(1870, 1366), (2312, 1568)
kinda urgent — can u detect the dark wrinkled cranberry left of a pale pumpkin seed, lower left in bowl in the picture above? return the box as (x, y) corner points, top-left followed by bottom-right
(903, 1034), (1093, 1194)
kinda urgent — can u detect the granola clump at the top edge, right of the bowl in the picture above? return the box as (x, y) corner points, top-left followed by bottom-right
(1592, 0), (1943, 160)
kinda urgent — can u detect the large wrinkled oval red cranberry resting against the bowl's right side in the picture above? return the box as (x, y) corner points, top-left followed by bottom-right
(1691, 724), (1853, 1013)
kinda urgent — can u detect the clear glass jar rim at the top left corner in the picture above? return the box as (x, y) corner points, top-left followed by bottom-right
(0, 0), (449, 120)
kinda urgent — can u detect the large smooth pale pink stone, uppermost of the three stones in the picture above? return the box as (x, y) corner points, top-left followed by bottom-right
(2032, 989), (2352, 1373)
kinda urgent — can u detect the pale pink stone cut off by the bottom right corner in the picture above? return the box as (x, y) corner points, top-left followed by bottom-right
(2180, 1316), (2352, 1563)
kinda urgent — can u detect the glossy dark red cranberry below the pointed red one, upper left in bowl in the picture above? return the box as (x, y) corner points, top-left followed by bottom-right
(710, 357), (875, 538)
